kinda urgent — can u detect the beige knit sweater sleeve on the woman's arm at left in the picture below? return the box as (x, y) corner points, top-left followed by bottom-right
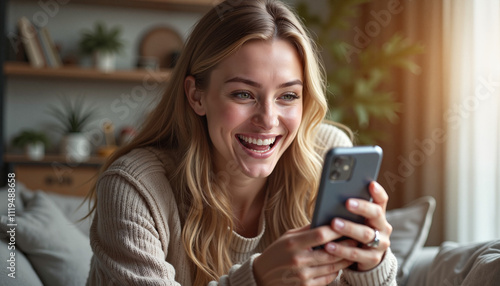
(87, 172), (180, 285)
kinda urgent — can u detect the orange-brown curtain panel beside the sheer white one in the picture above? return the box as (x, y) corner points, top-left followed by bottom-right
(354, 0), (447, 245)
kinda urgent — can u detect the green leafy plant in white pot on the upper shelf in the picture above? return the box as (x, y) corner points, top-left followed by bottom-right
(80, 22), (124, 72)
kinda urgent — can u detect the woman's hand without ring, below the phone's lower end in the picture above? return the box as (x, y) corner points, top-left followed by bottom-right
(253, 226), (357, 285)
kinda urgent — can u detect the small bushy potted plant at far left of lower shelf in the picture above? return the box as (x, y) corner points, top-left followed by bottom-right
(12, 129), (49, 161)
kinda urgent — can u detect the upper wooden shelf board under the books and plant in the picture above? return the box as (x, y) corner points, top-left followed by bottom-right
(4, 62), (170, 82)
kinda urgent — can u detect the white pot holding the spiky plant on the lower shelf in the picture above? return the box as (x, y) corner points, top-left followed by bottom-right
(61, 133), (91, 162)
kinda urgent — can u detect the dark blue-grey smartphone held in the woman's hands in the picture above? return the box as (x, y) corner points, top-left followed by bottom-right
(311, 146), (383, 247)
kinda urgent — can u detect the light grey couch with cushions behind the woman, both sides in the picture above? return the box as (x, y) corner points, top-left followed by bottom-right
(0, 183), (500, 286)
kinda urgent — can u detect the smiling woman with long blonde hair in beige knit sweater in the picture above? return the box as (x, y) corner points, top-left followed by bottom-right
(87, 0), (397, 285)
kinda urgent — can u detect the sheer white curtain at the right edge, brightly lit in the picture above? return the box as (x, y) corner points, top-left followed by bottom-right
(443, 0), (500, 242)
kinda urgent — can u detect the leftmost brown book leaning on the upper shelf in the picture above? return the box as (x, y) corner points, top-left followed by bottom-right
(18, 17), (45, 68)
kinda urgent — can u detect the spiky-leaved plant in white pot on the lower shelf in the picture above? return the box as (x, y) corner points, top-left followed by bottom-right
(49, 97), (96, 162)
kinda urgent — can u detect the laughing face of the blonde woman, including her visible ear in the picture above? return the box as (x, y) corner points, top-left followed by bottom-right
(191, 40), (303, 178)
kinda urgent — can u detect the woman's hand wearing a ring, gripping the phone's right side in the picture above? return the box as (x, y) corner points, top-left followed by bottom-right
(325, 182), (392, 271)
